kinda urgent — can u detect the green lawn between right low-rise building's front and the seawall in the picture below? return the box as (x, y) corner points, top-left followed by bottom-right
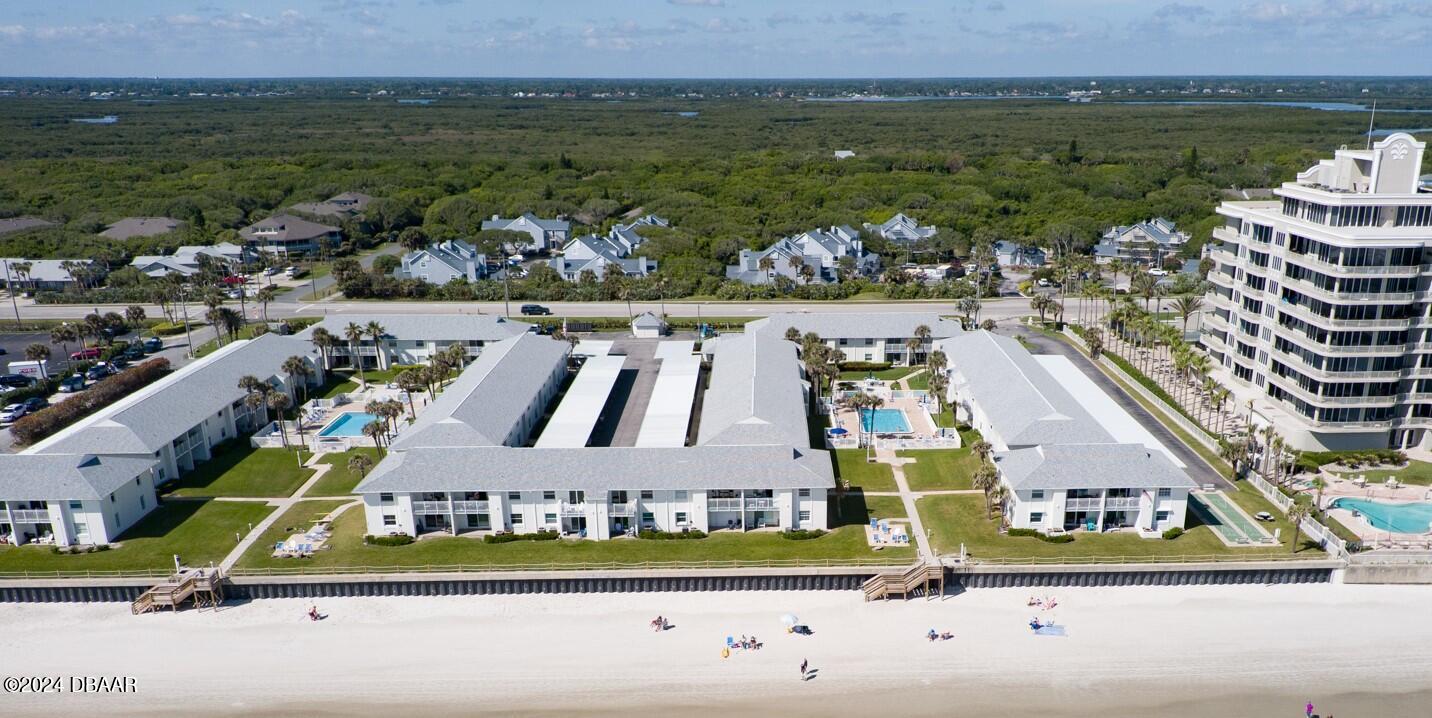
(916, 492), (1323, 560)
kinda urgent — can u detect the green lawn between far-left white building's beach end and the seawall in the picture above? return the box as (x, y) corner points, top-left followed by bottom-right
(0, 502), (274, 573)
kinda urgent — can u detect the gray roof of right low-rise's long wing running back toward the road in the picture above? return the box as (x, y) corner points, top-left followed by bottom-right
(935, 330), (1114, 447)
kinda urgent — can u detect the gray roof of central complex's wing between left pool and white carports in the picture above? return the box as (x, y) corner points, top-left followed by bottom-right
(392, 332), (569, 447)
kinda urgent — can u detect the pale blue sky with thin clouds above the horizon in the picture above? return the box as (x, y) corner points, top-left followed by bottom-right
(0, 0), (1432, 77)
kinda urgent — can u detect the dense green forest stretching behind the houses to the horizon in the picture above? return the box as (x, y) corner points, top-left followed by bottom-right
(0, 91), (1432, 291)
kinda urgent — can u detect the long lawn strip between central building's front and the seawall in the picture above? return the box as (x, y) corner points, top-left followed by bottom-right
(231, 507), (915, 569)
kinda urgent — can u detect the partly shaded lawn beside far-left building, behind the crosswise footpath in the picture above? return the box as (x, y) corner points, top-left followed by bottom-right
(170, 439), (314, 497)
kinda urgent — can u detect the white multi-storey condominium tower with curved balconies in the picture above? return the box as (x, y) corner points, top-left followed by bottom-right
(1203, 133), (1432, 450)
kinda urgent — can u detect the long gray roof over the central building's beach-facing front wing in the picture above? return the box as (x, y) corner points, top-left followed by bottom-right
(355, 446), (835, 493)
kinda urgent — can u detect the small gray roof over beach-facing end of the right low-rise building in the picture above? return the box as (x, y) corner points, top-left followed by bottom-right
(994, 444), (1197, 490)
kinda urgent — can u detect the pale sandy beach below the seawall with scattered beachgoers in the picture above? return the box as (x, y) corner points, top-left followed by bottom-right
(0, 585), (1432, 718)
